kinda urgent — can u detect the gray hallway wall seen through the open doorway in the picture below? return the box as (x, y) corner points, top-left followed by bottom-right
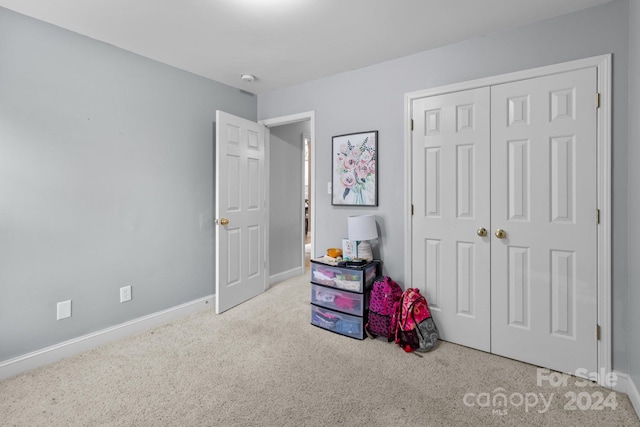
(269, 121), (310, 276)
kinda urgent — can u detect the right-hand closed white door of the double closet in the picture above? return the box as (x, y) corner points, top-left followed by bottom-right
(490, 68), (597, 372)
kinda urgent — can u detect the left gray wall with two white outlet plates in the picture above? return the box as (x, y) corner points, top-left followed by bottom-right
(0, 8), (257, 361)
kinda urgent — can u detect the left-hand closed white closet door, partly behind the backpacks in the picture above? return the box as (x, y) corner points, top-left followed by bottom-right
(412, 87), (491, 351)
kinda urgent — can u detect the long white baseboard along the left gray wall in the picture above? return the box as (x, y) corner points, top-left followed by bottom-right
(0, 295), (215, 380)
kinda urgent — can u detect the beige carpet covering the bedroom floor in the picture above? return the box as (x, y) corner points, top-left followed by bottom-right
(0, 277), (640, 427)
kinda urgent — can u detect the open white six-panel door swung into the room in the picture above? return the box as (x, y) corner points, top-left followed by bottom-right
(215, 111), (268, 313)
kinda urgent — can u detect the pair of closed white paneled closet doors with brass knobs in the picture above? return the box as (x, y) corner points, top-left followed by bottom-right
(412, 68), (597, 372)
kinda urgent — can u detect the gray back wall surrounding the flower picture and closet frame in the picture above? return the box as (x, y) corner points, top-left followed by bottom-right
(258, 0), (637, 371)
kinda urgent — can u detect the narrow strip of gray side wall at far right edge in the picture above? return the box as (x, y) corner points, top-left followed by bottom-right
(627, 0), (640, 387)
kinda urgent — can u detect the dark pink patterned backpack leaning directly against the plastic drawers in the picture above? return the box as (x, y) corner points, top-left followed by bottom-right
(364, 276), (402, 341)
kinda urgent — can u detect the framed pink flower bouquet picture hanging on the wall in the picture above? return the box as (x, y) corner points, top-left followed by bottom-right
(331, 130), (378, 206)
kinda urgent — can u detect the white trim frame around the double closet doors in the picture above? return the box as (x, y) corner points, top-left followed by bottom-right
(404, 54), (612, 385)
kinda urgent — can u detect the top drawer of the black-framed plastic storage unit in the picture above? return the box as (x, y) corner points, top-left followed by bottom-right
(311, 260), (378, 292)
